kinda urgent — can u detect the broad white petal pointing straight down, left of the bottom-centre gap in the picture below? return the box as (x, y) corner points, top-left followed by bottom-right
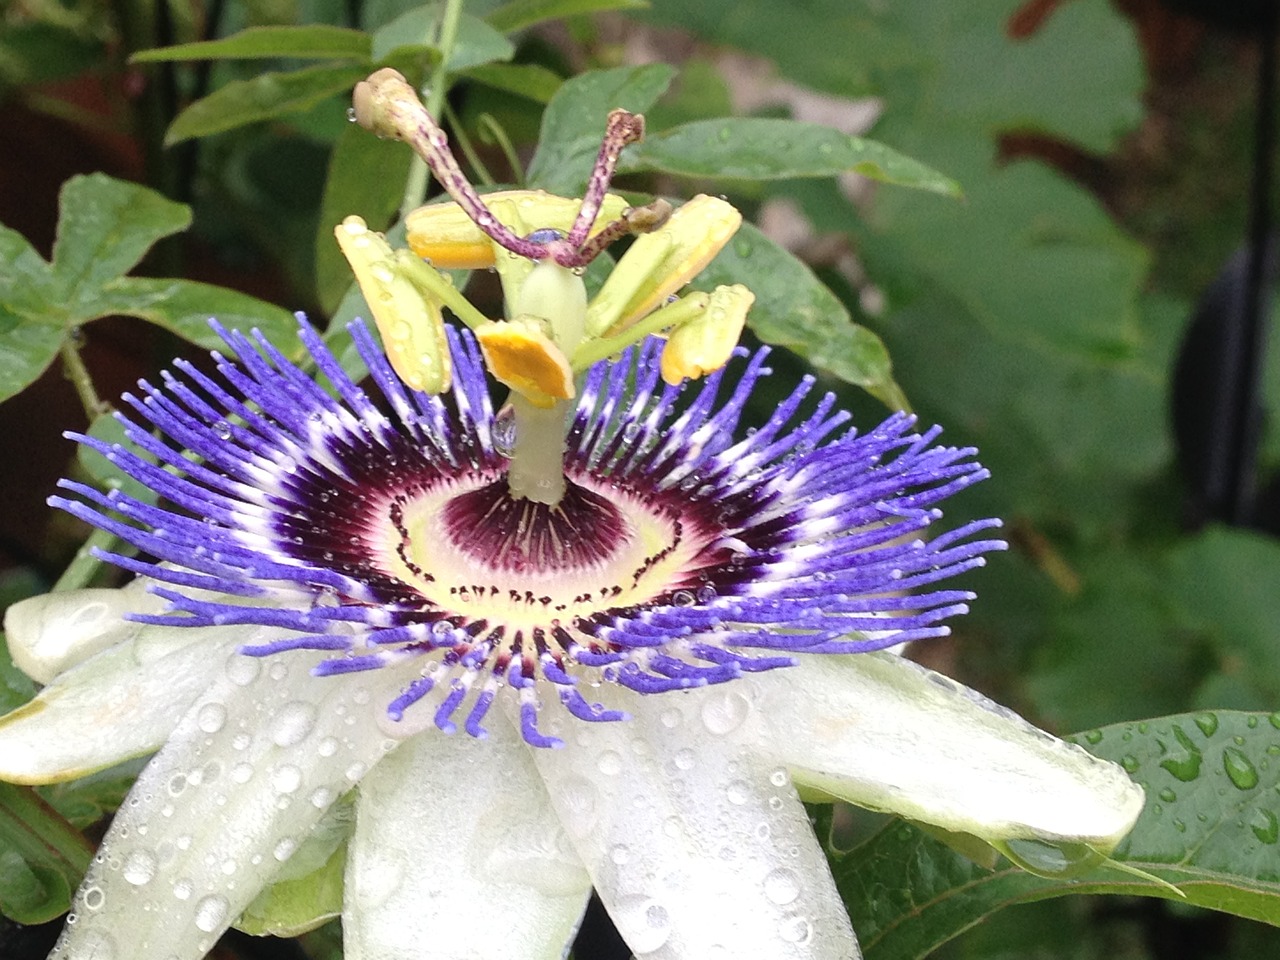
(343, 710), (591, 960)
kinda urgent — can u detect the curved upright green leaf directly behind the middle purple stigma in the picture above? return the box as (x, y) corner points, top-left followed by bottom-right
(526, 64), (676, 197)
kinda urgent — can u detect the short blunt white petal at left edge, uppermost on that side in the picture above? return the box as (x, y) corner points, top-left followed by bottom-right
(4, 579), (165, 684)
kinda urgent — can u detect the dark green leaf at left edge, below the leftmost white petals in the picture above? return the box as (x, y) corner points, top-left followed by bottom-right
(0, 782), (93, 924)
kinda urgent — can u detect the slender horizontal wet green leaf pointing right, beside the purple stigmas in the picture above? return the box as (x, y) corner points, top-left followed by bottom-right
(618, 116), (960, 196)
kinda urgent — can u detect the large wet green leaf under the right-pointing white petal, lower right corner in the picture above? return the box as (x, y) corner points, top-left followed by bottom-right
(833, 712), (1280, 960)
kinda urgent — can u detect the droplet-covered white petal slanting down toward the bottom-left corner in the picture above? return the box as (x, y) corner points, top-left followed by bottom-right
(43, 653), (404, 960)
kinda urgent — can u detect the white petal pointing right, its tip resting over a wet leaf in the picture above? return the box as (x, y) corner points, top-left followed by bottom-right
(747, 653), (1143, 850)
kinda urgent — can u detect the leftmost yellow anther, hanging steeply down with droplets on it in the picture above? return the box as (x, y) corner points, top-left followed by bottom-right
(334, 216), (453, 393)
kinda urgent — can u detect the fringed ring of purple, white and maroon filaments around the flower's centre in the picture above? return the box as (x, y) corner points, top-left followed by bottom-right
(50, 323), (1004, 746)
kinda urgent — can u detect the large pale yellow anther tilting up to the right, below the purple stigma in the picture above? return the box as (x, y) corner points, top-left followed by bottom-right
(586, 193), (742, 337)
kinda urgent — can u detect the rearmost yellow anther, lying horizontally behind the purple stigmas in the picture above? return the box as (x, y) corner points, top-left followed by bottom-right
(404, 189), (627, 270)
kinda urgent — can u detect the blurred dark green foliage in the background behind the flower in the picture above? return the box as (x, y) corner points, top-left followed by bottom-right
(0, 0), (1280, 960)
